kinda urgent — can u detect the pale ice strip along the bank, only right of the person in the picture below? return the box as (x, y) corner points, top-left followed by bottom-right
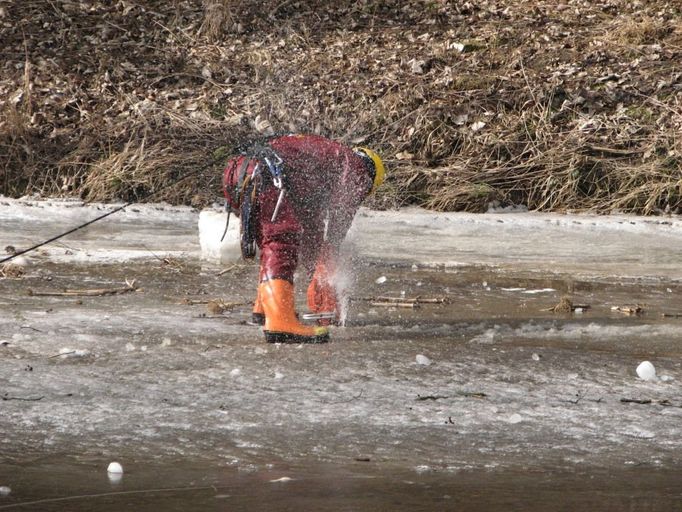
(350, 208), (682, 280)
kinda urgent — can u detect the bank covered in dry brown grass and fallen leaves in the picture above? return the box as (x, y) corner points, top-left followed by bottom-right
(0, 0), (682, 213)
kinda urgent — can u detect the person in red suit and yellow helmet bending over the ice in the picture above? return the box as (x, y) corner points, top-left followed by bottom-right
(223, 134), (385, 343)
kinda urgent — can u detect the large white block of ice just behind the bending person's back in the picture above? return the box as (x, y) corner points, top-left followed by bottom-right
(199, 210), (242, 263)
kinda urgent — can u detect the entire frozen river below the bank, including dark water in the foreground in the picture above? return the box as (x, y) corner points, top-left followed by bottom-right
(0, 198), (682, 510)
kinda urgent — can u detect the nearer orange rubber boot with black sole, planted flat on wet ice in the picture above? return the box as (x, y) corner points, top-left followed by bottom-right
(258, 279), (329, 343)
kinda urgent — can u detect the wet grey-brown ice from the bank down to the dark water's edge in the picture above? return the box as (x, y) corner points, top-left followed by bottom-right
(0, 197), (682, 476)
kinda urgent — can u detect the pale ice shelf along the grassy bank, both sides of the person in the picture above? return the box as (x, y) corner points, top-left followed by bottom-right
(0, 197), (682, 280)
